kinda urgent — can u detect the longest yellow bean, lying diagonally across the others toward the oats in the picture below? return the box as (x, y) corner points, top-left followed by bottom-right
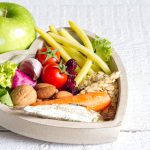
(48, 33), (111, 74)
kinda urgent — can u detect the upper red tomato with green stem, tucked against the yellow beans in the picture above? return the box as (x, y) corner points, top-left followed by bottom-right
(36, 46), (60, 66)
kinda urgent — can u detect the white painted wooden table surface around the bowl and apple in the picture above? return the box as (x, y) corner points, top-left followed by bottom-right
(0, 0), (150, 150)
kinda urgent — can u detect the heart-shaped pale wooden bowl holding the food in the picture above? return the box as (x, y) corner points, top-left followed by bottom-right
(0, 27), (127, 144)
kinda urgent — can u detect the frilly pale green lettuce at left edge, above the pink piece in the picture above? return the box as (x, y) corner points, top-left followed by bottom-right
(0, 61), (17, 88)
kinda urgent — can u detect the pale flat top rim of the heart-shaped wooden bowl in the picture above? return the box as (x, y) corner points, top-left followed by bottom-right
(0, 27), (127, 128)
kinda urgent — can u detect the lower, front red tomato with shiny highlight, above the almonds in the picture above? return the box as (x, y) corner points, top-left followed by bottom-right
(42, 64), (68, 89)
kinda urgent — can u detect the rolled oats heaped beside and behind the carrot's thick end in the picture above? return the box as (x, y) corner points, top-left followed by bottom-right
(79, 72), (120, 120)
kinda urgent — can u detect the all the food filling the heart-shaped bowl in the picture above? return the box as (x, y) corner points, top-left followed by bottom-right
(0, 21), (119, 122)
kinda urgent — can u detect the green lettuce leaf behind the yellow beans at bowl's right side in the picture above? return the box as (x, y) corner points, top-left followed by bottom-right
(92, 36), (112, 64)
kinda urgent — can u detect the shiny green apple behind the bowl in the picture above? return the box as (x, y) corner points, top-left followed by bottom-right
(0, 2), (36, 53)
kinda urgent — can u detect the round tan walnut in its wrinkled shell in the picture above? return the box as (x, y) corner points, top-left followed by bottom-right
(10, 85), (37, 107)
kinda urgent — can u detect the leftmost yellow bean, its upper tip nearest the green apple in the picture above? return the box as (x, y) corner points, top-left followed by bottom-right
(35, 28), (71, 61)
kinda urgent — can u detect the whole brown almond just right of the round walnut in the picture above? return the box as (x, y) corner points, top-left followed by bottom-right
(37, 86), (57, 99)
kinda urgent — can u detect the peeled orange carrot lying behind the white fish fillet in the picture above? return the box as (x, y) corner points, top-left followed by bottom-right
(32, 92), (111, 111)
